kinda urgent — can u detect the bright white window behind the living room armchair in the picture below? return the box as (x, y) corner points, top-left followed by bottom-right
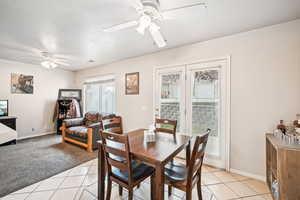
(84, 76), (116, 113)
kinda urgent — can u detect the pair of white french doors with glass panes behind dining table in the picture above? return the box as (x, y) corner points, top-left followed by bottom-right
(155, 59), (229, 169)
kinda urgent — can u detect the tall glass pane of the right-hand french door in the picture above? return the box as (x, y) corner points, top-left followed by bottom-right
(191, 69), (221, 157)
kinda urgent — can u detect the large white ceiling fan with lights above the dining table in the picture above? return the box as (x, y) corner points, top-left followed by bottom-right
(103, 0), (206, 48)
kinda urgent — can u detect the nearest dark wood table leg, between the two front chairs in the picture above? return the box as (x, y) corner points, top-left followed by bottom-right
(155, 165), (165, 200)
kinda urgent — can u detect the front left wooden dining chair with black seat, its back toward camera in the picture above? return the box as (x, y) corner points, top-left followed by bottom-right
(101, 131), (155, 200)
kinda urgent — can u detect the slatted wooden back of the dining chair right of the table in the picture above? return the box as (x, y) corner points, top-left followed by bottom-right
(187, 129), (211, 183)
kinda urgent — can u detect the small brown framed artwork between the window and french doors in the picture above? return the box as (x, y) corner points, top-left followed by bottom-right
(125, 72), (140, 95)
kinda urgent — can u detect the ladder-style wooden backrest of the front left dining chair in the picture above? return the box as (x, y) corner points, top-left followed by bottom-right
(101, 131), (133, 184)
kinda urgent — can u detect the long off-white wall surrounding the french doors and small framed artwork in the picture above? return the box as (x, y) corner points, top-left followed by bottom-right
(76, 20), (300, 176)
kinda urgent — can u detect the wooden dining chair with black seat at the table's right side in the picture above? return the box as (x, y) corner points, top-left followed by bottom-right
(165, 129), (211, 200)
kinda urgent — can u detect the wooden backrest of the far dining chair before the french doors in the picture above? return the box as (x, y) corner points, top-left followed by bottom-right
(155, 119), (177, 140)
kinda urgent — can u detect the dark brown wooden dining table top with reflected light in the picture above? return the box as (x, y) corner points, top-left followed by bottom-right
(127, 129), (191, 164)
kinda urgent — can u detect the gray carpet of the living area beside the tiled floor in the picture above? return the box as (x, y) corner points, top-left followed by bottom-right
(0, 134), (97, 198)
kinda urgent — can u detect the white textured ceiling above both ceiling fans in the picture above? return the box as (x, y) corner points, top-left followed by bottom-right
(0, 0), (300, 70)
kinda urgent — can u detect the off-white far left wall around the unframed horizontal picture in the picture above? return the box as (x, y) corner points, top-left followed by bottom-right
(0, 60), (75, 138)
